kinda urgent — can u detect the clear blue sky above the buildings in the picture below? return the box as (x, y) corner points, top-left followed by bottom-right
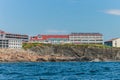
(0, 0), (120, 40)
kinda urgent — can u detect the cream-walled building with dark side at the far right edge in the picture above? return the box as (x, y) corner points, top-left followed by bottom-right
(104, 38), (120, 47)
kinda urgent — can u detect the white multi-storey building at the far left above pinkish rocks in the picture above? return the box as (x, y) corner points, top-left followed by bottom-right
(0, 30), (29, 48)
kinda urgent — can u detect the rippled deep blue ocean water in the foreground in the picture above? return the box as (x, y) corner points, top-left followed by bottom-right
(0, 62), (120, 80)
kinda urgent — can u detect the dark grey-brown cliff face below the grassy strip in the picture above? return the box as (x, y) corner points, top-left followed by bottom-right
(30, 46), (120, 61)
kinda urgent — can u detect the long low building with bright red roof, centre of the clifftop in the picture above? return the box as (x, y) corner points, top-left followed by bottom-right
(30, 35), (69, 44)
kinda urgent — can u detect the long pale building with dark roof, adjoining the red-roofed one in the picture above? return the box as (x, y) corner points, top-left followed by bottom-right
(69, 33), (103, 44)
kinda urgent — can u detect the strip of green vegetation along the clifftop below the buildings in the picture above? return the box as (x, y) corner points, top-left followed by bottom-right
(23, 43), (111, 49)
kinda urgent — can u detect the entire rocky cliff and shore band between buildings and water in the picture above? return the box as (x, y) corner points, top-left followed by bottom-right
(0, 45), (120, 62)
